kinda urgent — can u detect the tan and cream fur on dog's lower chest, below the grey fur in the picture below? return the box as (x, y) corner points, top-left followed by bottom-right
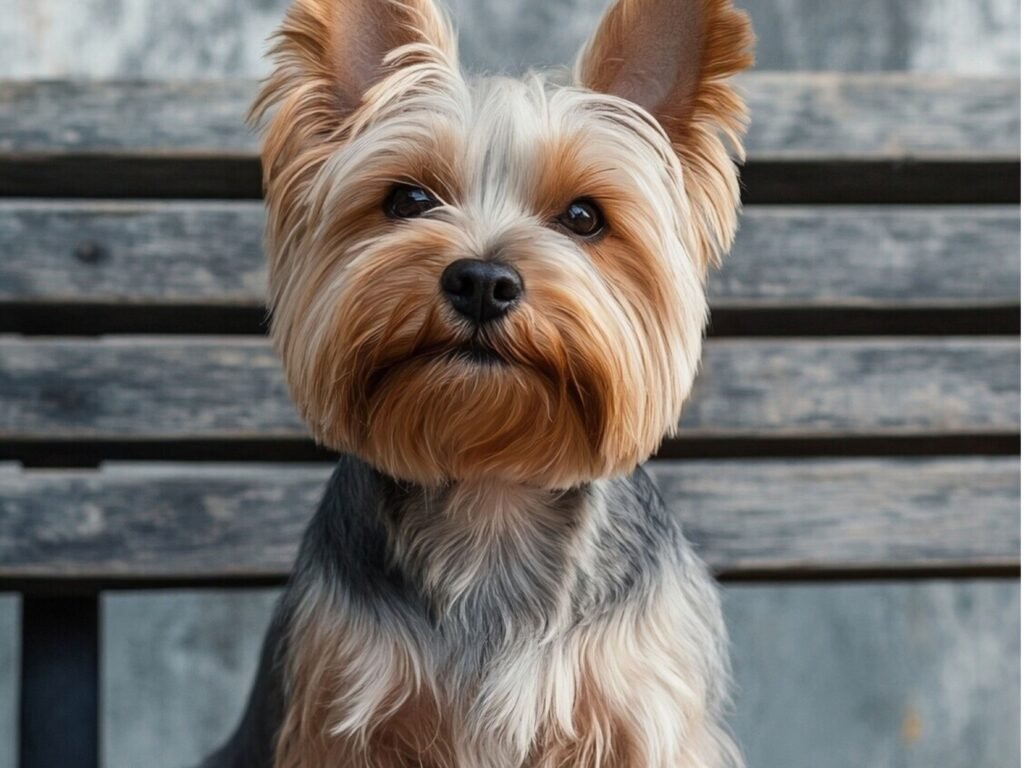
(275, 544), (740, 768)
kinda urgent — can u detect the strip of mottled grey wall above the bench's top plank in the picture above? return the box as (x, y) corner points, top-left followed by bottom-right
(0, 0), (1020, 79)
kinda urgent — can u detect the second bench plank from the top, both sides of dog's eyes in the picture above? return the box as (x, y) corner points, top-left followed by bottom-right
(6, 200), (1020, 308)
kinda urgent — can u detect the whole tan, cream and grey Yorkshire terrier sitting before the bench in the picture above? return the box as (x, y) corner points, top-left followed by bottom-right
(205, 0), (753, 768)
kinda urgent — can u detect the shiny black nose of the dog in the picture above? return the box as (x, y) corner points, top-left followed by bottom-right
(441, 259), (522, 323)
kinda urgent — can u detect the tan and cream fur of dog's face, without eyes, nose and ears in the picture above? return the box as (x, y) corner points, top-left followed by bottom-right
(253, 52), (720, 487)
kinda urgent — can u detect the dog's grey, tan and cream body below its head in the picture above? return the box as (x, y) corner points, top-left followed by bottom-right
(210, 458), (733, 768)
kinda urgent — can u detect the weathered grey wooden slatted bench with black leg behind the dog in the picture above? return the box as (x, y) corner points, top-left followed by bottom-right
(0, 74), (1020, 768)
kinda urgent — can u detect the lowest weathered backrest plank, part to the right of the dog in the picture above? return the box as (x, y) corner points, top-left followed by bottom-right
(649, 458), (1020, 571)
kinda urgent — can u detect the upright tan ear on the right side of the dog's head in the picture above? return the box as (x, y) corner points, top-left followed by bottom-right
(575, 0), (754, 270)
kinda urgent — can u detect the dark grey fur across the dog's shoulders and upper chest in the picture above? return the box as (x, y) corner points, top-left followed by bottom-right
(203, 457), (707, 768)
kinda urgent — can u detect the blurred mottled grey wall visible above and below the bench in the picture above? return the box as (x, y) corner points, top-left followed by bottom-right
(0, 0), (1021, 768)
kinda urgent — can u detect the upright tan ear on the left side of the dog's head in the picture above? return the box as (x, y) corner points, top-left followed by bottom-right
(250, 0), (458, 183)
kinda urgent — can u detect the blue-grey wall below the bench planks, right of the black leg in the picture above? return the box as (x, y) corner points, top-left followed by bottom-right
(94, 581), (1020, 768)
